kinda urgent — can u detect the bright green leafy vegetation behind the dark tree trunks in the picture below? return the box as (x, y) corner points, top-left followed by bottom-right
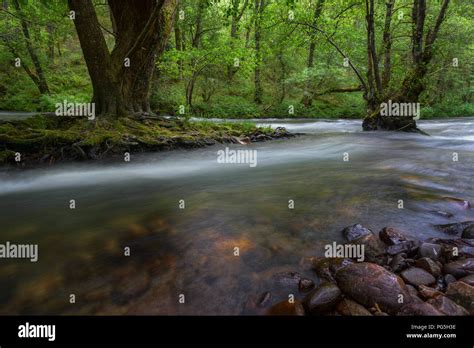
(0, 0), (474, 119)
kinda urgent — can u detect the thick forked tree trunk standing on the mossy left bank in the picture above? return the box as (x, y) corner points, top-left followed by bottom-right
(68, 0), (178, 116)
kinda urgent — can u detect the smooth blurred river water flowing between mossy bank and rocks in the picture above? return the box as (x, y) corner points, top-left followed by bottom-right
(0, 118), (474, 314)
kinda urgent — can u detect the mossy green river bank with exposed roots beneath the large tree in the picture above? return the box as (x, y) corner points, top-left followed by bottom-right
(0, 115), (293, 167)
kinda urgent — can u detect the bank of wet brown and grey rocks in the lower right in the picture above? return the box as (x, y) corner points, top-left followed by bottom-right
(260, 221), (474, 316)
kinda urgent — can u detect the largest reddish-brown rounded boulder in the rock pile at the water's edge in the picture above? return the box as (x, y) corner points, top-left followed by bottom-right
(336, 262), (411, 313)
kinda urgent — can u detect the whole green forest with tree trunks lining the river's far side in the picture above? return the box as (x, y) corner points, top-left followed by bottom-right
(0, 0), (474, 125)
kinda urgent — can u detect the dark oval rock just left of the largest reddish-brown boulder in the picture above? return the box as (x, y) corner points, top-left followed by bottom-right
(303, 282), (342, 314)
